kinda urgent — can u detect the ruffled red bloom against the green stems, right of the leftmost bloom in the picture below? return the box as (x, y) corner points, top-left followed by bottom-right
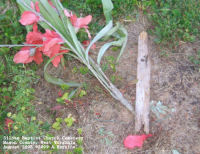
(43, 29), (68, 67)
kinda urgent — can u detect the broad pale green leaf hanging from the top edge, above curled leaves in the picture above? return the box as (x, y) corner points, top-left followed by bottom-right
(102, 0), (113, 24)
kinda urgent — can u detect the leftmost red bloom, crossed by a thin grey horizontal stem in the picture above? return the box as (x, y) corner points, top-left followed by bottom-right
(13, 24), (43, 64)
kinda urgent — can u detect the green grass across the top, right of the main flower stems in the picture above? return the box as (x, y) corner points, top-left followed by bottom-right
(63, 0), (200, 48)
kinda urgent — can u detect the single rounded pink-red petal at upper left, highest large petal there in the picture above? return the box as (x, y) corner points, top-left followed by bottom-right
(19, 11), (39, 26)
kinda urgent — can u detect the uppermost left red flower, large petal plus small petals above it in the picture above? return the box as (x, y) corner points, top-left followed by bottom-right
(19, 1), (40, 26)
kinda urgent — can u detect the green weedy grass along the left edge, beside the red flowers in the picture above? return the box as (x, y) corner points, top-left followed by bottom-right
(0, 1), (44, 153)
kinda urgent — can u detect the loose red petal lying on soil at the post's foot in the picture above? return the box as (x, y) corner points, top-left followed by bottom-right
(124, 134), (152, 149)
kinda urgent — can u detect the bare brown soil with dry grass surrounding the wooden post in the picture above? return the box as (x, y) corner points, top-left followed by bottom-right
(32, 13), (200, 154)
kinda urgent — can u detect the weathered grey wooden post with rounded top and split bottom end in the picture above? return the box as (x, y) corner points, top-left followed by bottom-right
(135, 31), (150, 133)
